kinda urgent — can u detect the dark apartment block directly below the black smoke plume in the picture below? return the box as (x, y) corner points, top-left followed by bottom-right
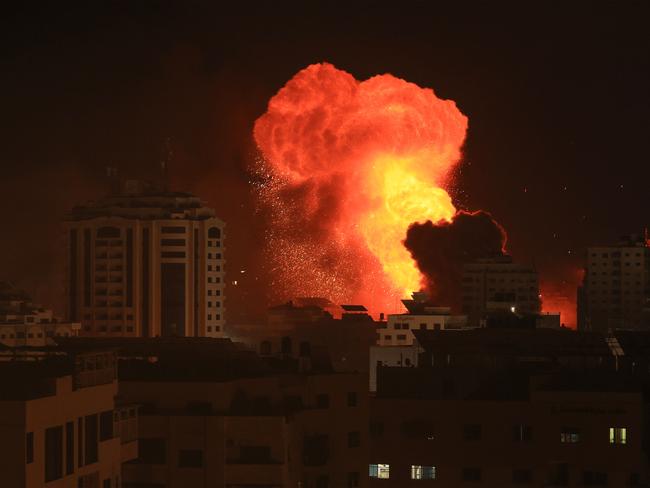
(461, 256), (541, 325)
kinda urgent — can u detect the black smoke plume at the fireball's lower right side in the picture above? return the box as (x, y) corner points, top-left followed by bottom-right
(404, 210), (507, 311)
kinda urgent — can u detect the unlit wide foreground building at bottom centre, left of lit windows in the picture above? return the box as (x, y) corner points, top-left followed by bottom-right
(62, 338), (369, 488)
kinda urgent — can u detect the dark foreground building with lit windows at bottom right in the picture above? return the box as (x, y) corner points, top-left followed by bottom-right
(369, 328), (649, 488)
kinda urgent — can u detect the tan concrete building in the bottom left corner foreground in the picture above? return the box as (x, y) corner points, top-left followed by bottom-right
(0, 350), (138, 488)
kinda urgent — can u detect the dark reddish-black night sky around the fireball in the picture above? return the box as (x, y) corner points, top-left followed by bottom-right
(0, 1), (650, 320)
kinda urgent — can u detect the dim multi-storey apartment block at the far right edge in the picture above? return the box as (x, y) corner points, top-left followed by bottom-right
(578, 236), (650, 331)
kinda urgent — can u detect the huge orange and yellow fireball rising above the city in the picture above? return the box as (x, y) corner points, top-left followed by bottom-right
(254, 64), (467, 312)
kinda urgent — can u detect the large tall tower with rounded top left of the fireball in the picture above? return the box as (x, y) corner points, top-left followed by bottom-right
(66, 181), (225, 337)
